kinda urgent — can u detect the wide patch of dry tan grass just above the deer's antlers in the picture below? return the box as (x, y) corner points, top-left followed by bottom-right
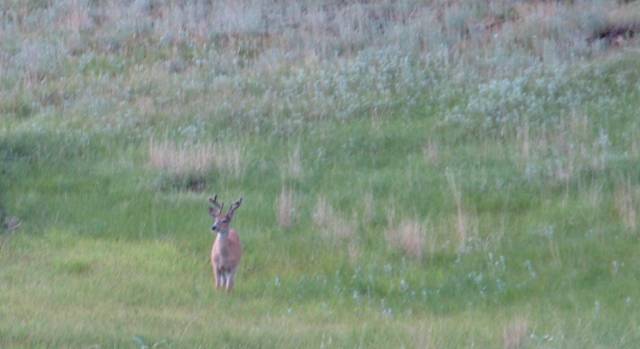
(149, 139), (244, 177)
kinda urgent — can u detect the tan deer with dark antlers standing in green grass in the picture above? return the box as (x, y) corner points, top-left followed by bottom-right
(209, 195), (242, 292)
